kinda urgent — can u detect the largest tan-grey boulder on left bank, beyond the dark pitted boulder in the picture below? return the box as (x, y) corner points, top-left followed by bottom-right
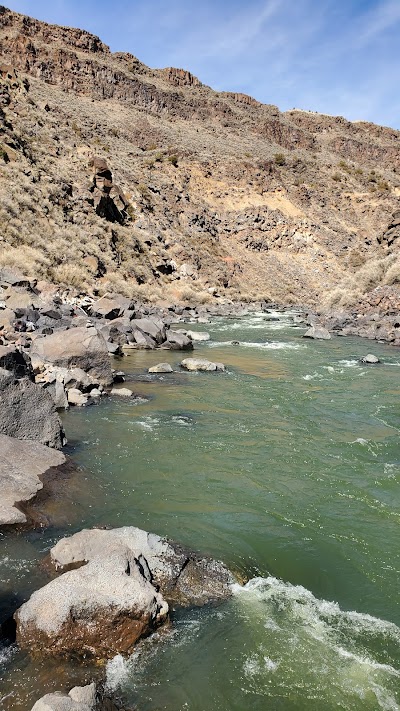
(31, 327), (112, 386)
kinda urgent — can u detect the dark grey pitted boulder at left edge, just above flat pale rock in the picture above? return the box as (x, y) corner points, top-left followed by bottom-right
(0, 368), (65, 449)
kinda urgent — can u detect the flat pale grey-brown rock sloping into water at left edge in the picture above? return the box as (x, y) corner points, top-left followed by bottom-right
(0, 434), (66, 526)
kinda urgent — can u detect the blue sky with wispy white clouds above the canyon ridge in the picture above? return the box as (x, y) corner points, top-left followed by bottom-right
(3, 0), (400, 129)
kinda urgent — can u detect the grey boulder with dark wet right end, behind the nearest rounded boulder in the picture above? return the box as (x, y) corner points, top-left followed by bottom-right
(50, 526), (233, 606)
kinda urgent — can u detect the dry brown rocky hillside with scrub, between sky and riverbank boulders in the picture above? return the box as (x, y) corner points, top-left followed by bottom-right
(0, 7), (400, 308)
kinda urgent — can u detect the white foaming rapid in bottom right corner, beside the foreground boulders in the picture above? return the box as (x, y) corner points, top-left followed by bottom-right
(107, 576), (400, 711)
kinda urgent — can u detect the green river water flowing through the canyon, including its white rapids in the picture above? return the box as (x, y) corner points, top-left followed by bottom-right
(0, 313), (400, 711)
